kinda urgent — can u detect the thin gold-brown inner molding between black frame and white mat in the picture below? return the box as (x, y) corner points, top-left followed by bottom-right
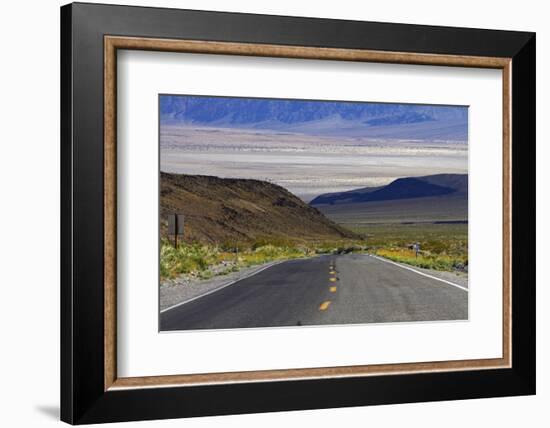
(104, 36), (512, 391)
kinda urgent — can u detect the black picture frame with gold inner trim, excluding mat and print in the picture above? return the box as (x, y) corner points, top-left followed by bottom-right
(61, 4), (535, 424)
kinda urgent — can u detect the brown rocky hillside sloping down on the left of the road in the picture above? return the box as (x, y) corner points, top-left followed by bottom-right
(160, 172), (357, 245)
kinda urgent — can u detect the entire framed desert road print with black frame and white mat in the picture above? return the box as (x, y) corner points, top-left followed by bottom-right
(61, 3), (535, 424)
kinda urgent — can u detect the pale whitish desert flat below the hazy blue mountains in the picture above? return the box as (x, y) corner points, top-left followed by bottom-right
(160, 125), (468, 201)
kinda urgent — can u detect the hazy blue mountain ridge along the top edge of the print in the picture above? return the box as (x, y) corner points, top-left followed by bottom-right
(160, 95), (468, 141)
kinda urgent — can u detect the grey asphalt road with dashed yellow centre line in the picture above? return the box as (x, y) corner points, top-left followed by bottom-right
(160, 254), (468, 331)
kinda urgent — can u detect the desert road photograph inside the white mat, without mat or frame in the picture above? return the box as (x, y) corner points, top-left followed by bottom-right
(159, 94), (468, 331)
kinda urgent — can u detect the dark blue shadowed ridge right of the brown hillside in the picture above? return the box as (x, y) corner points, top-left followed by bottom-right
(310, 174), (468, 206)
